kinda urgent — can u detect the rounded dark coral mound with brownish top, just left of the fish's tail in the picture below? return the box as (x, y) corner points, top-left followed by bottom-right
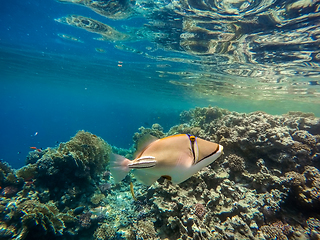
(23, 131), (111, 204)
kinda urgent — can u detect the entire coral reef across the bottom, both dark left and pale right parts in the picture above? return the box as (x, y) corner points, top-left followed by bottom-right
(0, 107), (320, 240)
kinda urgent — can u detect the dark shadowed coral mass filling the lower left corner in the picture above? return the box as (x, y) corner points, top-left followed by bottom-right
(0, 131), (111, 240)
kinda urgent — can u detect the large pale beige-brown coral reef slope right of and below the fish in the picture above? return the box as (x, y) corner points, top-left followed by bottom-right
(123, 107), (320, 239)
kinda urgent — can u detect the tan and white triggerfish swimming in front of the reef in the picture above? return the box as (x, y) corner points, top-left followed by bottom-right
(110, 134), (223, 186)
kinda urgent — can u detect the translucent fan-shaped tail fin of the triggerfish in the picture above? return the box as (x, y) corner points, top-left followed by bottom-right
(110, 154), (131, 183)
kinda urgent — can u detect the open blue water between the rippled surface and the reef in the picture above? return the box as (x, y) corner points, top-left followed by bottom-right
(0, 0), (320, 168)
